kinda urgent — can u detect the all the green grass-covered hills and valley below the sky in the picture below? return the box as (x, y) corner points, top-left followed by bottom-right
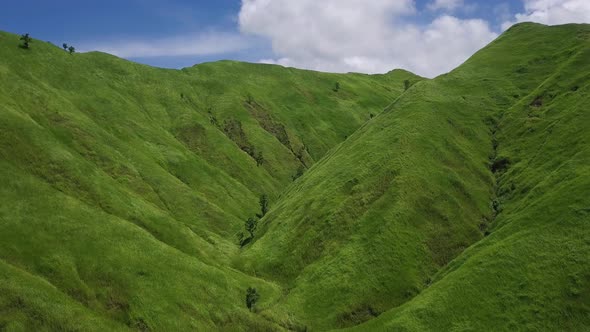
(0, 24), (590, 331)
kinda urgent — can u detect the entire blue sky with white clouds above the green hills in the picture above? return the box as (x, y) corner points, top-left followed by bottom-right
(0, 0), (590, 76)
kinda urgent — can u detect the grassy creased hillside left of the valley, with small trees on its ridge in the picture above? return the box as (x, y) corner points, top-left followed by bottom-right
(0, 29), (420, 330)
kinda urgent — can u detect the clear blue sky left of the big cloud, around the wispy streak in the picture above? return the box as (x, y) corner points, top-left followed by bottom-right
(0, 0), (264, 68)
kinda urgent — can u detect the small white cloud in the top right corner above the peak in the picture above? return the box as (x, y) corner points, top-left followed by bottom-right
(502, 0), (590, 29)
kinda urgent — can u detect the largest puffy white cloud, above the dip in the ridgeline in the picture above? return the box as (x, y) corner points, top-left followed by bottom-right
(239, 0), (497, 77)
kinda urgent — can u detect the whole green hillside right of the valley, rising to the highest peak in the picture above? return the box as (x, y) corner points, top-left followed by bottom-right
(236, 24), (590, 331)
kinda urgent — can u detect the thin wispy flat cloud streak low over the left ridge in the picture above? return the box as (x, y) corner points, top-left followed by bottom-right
(80, 32), (251, 58)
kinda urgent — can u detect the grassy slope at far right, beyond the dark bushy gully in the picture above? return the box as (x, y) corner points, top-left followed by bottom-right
(358, 25), (590, 331)
